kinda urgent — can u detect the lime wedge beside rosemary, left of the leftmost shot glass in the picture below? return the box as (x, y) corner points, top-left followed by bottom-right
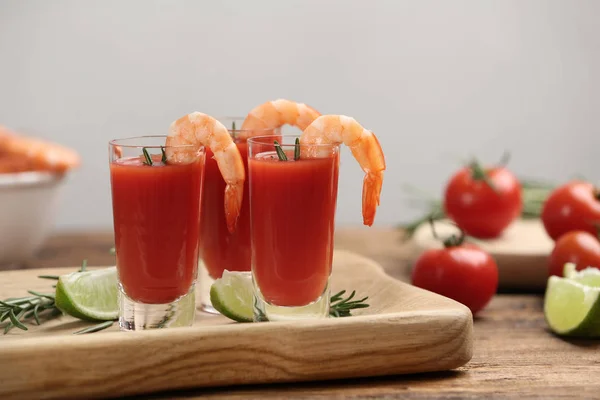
(56, 267), (119, 321)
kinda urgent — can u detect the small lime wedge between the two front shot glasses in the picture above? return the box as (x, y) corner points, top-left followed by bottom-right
(210, 270), (254, 322)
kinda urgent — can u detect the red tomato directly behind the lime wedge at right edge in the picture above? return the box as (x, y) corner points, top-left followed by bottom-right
(548, 231), (600, 276)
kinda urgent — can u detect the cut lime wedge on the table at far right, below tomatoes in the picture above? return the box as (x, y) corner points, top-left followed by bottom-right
(544, 274), (600, 337)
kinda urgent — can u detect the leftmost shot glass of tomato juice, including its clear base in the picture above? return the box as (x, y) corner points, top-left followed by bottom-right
(109, 136), (205, 330)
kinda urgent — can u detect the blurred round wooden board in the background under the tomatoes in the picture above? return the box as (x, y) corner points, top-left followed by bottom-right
(413, 220), (554, 290)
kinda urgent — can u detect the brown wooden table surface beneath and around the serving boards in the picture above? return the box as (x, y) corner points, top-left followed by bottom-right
(5, 228), (600, 399)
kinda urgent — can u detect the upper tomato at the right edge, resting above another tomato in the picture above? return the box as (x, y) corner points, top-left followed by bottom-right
(541, 181), (600, 240)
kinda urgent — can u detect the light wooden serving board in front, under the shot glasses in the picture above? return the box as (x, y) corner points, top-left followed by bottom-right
(0, 250), (473, 399)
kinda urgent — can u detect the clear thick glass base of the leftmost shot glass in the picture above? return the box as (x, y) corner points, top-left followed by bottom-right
(119, 285), (196, 331)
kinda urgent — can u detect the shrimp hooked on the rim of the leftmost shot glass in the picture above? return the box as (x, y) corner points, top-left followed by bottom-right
(165, 112), (246, 232)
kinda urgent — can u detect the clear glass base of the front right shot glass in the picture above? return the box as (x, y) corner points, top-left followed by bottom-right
(254, 283), (330, 322)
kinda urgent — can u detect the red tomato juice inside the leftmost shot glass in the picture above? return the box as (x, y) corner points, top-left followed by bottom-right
(110, 154), (205, 304)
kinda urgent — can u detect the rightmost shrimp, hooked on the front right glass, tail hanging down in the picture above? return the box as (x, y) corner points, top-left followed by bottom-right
(300, 115), (385, 226)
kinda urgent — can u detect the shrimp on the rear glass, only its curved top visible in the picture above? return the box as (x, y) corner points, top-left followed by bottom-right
(242, 99), (321, 136)
